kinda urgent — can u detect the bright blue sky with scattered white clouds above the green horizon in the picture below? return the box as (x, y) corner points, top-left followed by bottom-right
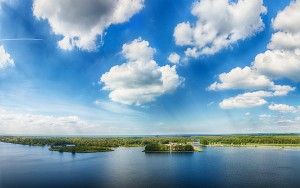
(0, 0), (300, 135)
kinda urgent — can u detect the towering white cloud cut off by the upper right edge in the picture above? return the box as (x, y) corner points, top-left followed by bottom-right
(253, 0), (300, 82)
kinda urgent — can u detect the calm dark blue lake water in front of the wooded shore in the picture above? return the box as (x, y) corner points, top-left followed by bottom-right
(0, 143), (300, 188)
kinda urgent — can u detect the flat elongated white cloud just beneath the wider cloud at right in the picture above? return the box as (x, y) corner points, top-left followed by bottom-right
(219, 91), (273, 109)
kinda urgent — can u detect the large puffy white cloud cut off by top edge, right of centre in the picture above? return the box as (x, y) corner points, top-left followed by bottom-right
(173, 0), (267, 57)
